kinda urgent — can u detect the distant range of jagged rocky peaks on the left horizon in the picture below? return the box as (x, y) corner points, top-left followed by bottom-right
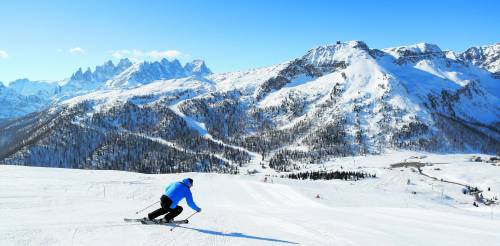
(0, 58), (211, 119)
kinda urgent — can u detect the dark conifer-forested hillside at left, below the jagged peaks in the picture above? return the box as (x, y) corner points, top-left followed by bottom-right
(3, 99), (243, 173)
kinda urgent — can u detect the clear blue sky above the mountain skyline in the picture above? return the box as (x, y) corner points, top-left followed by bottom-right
(0, 0), (500, 82)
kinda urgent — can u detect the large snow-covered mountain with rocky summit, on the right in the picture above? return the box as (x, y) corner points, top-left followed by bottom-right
(204, 41), (500, 156)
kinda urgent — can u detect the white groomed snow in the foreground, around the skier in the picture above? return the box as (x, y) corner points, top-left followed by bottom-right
(0, 152), (500, 246)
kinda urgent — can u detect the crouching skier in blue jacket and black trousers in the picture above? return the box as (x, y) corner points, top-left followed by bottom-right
(144, 178), (201, 223)
